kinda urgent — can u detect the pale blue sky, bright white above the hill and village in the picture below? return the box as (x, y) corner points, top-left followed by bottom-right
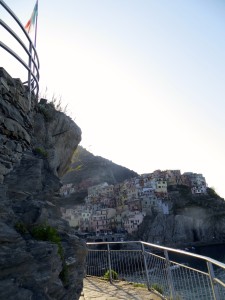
(0, 0), (225, 198)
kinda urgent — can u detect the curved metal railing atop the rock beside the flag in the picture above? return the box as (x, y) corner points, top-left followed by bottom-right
(0, 0), (40, 96)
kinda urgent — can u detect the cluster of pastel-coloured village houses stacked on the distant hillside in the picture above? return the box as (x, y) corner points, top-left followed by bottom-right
(60, 170), (207, 240)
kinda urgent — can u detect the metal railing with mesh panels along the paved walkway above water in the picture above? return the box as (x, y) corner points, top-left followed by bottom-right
(86, 241), (225, 300)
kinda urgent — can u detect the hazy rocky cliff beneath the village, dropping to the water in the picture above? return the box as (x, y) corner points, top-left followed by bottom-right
(137, 186), (225, 247)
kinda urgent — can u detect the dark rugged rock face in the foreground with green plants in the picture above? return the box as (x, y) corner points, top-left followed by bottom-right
(0, 68), (87, 300)
